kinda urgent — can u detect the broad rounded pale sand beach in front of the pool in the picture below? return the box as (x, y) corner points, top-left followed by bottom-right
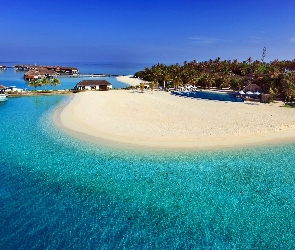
(58, 76), (295, 148)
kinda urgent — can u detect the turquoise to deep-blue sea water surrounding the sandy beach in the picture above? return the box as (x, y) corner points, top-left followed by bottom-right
(0, 63), (295, 249)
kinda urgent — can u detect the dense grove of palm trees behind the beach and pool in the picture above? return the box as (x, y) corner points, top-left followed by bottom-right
(135, 58), (295, 101)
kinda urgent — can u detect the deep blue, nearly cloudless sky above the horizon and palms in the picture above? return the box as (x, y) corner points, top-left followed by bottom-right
(0, 0), (295, 64)
